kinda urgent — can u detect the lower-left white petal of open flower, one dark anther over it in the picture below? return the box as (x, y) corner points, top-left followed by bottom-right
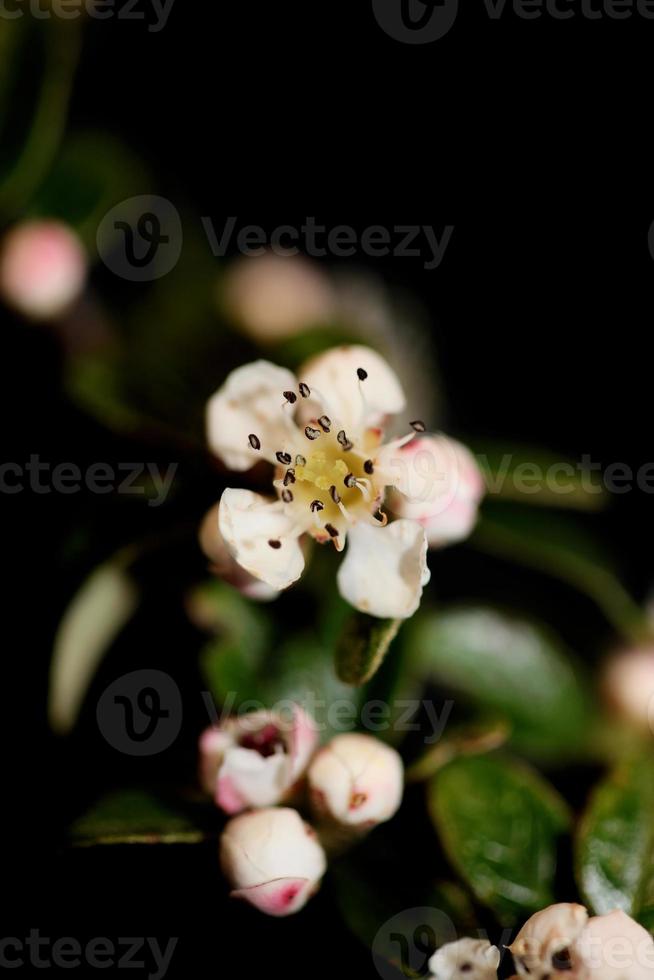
(218, 489), (304, 589)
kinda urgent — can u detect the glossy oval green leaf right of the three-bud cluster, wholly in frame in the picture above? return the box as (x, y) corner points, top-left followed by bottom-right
(428, 755), (569, 923)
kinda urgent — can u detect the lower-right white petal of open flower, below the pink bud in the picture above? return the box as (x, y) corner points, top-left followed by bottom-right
(338, 520), (429, 619)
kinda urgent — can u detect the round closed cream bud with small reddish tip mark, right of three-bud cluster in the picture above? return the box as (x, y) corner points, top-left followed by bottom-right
(308, 733), (404, 828)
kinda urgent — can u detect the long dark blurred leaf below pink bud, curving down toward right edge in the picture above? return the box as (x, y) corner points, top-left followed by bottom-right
(470, 501), (647, 639)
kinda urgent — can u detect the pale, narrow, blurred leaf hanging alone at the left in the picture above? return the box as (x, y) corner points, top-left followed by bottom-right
(48, 549), (138, 734)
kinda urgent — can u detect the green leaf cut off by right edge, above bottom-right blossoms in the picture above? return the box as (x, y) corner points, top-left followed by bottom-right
(576, 753), (654, 929)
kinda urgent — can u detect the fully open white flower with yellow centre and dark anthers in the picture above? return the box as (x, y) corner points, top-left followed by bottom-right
(207, 346), (429, 618)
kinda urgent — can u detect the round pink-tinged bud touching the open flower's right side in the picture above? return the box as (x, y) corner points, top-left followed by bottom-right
(389, 435), (485, 547)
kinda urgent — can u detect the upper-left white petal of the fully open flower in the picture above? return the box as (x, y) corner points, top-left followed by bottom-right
(207, 361), (297, 470)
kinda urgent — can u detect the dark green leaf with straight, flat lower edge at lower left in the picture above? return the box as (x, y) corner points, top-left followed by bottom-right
(69, 789), (217, 847)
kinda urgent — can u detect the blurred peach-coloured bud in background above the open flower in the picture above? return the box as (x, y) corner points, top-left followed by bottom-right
(224, 252), (334, 343)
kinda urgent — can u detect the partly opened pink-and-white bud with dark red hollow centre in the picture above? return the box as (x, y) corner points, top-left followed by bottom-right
(200, 705), (317, 814)
